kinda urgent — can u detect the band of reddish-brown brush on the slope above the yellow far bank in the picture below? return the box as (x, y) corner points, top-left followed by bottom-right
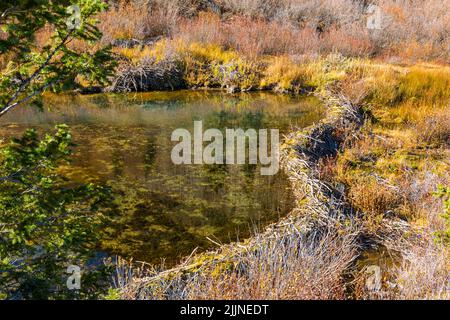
(100, 0), (450, 61)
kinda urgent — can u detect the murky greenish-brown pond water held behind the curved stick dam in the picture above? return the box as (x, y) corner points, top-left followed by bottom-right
(0, 91), (323, 263)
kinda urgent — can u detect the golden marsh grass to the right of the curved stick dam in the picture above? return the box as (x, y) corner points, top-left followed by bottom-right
(334, 64), (450, 299)
